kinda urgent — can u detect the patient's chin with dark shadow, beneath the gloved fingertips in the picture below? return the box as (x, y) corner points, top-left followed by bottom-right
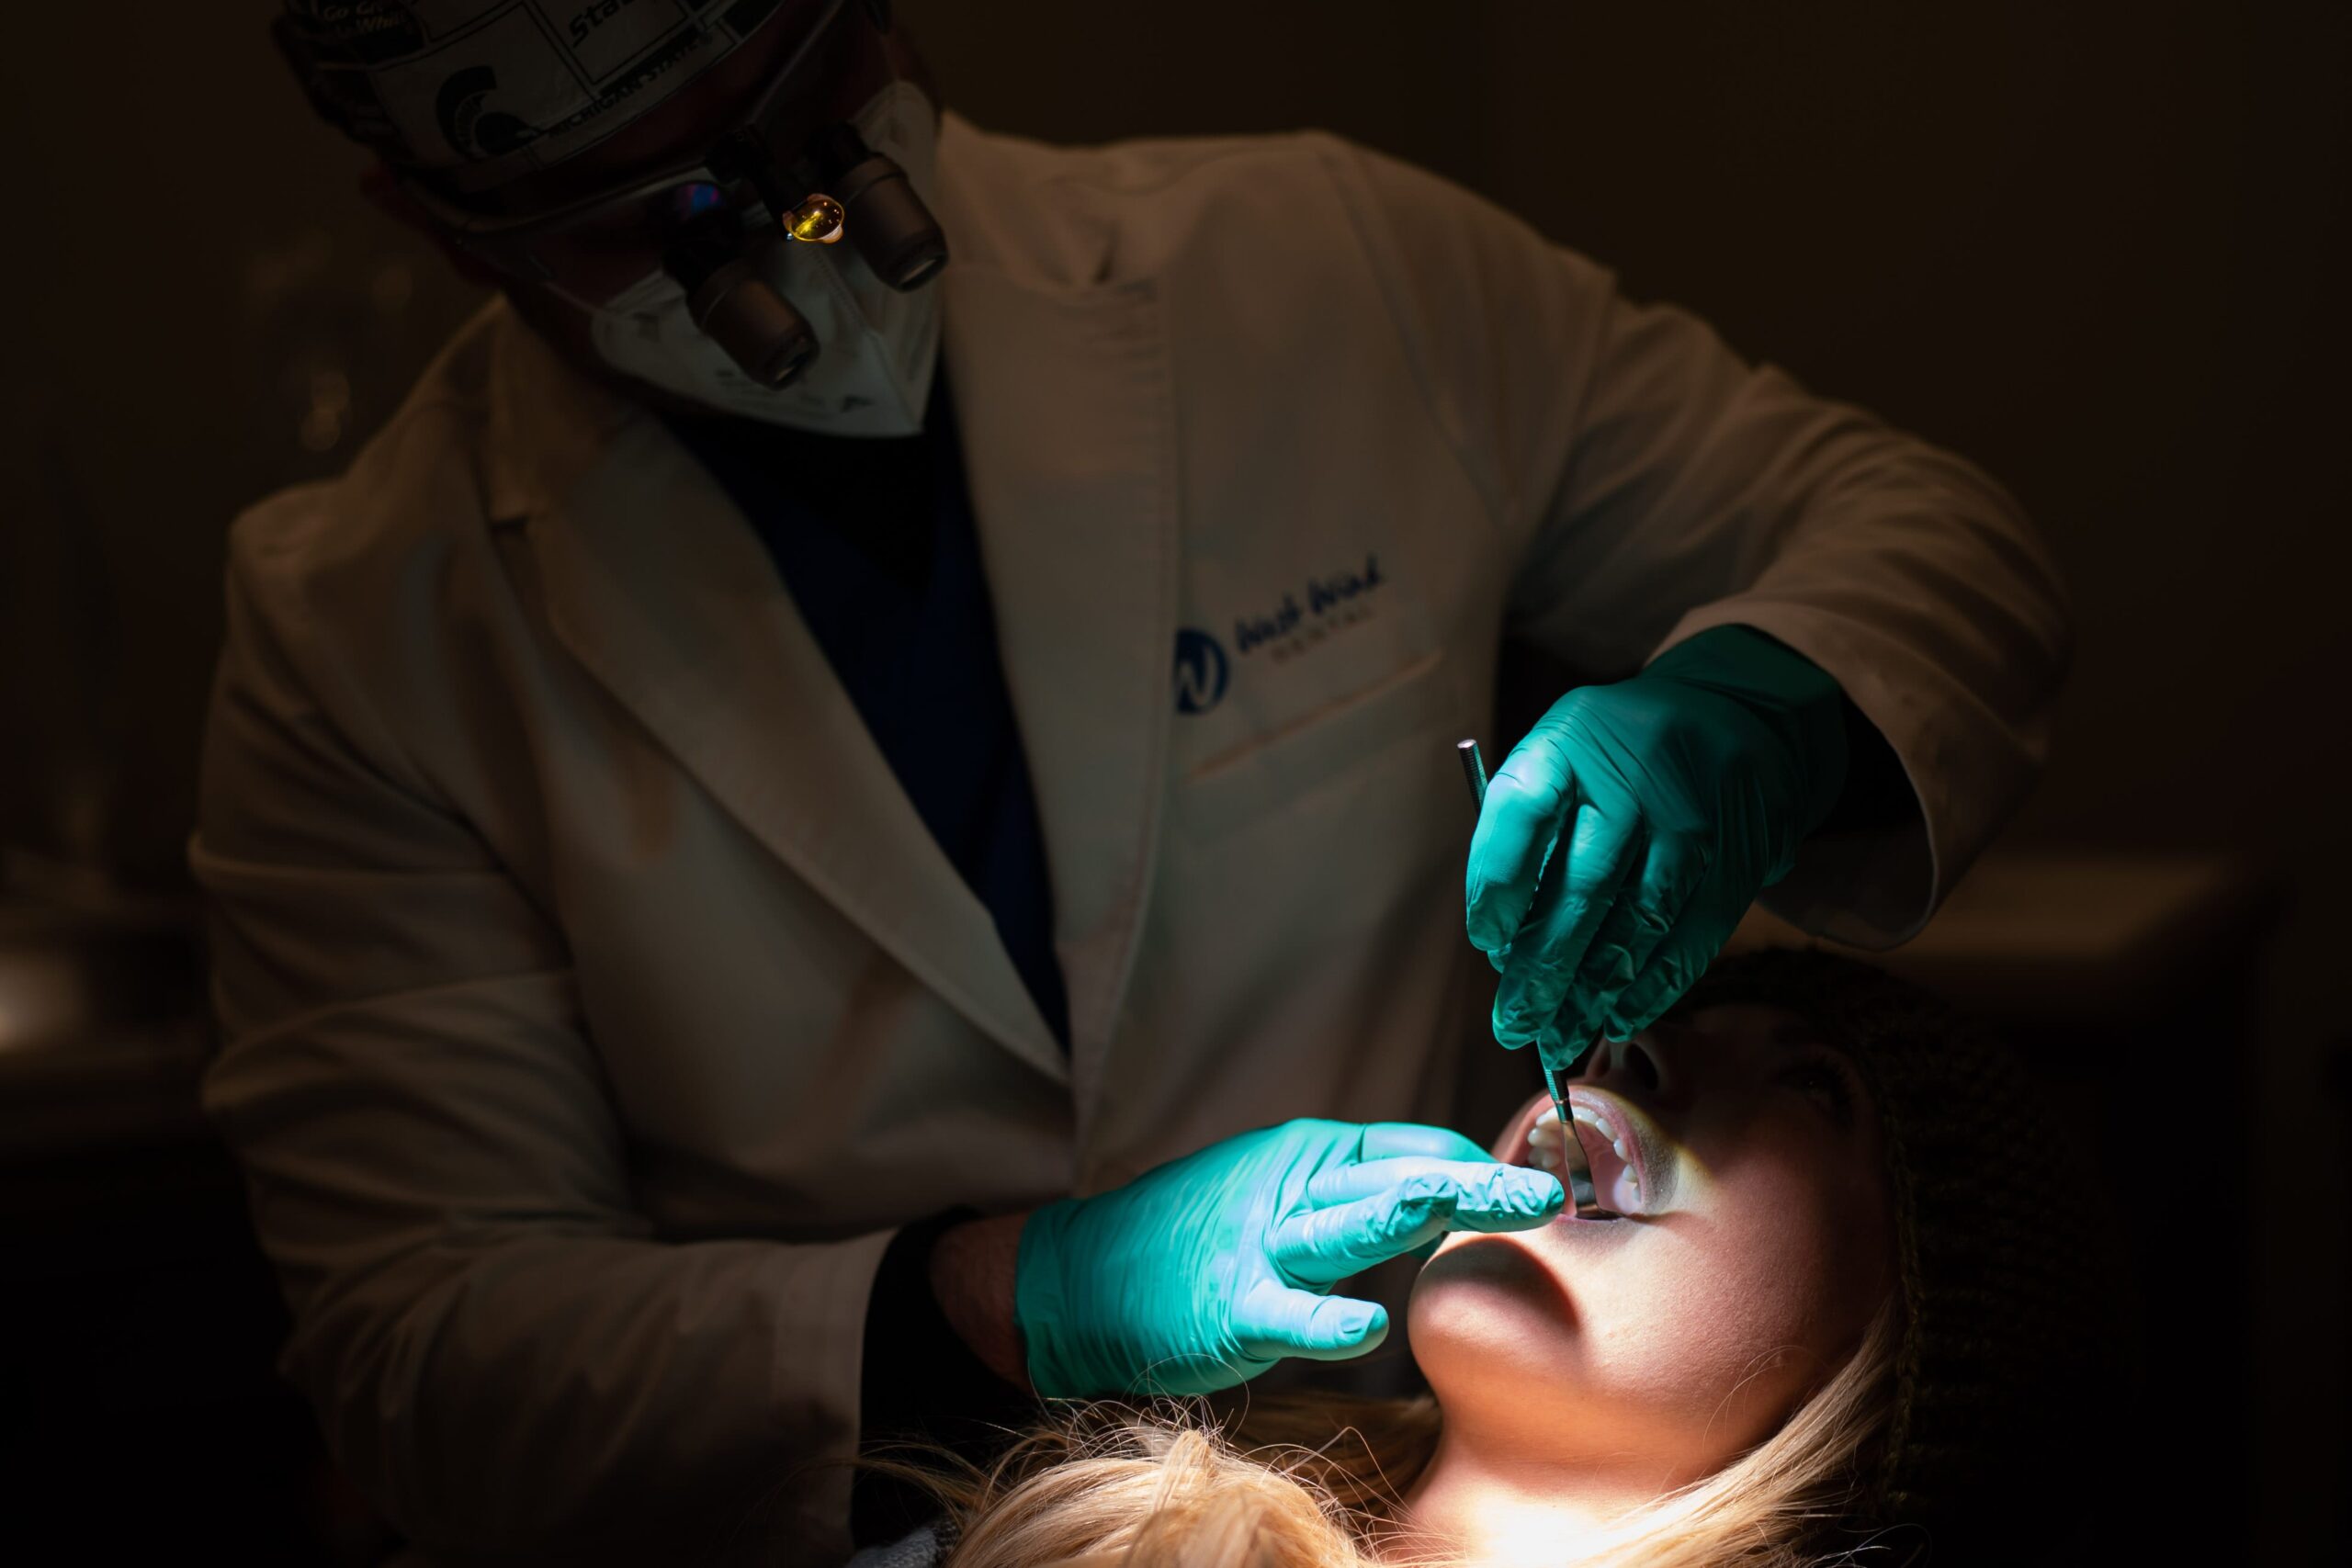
(1407, 1235), (1576, 1394)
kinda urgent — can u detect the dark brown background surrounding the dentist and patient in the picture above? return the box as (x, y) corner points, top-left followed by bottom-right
(0, 0), (2352, 1561)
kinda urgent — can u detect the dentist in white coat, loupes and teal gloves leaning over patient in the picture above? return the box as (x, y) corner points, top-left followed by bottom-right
(193, 0), (2065, 1561)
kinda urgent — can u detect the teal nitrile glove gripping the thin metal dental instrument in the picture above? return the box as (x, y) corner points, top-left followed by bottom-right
(1465, 626), (1847, 1063)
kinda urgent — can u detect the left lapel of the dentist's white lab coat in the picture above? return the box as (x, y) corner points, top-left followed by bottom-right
(529, 400), (1068, 1079)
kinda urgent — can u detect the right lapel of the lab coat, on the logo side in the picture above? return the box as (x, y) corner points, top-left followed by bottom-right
(944, 264), (1179, 1114)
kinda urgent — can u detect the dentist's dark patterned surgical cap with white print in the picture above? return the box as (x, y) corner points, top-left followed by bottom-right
(277, 0), (799, 190)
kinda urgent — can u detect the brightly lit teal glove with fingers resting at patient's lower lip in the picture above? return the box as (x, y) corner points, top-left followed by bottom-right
(1013, 1122), (1564, 1399)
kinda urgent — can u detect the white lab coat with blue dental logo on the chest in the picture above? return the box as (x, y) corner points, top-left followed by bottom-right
(193, 118), (2065, 1559)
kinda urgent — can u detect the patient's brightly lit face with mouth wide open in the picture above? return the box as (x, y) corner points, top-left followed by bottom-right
(1408, 1004), (1894, 1485)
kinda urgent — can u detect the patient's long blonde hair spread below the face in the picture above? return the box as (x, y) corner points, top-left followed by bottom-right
(870, 1303), (1898, 1568)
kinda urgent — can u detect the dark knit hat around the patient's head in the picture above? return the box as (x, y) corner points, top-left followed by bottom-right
(1681, 950), (2124, 1563)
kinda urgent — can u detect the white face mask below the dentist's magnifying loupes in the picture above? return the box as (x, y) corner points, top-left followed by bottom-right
(571, 83), (938, 434)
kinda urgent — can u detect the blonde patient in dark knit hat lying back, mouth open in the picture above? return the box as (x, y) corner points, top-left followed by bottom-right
(873, 952), (2112, 1568)
